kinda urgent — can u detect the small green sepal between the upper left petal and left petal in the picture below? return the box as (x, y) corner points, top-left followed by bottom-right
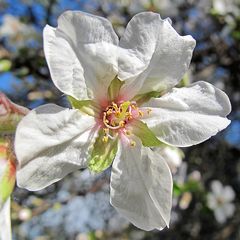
(67, 96), (99, 117)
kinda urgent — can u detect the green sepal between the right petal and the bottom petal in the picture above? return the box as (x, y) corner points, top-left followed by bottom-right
(131, 120), (165, 147)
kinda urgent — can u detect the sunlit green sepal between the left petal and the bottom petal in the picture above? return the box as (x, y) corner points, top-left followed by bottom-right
(88, 129), (118, 173)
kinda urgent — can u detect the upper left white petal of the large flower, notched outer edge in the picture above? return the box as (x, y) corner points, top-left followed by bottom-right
(44, 11), (118, 99)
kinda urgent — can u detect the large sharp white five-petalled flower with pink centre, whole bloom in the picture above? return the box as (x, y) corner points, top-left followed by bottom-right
(15, 11), (231, 230)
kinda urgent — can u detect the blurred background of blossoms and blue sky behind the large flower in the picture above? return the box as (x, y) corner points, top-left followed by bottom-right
(0, 0), (240, 240)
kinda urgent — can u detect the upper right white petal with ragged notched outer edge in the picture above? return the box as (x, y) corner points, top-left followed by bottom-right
(119, 12), (196, 97)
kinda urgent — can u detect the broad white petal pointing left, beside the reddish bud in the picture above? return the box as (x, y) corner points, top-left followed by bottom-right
(15, 104), (95, 191)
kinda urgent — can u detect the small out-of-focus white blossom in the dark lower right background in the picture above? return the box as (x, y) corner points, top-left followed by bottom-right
(207, 180), (235, 223)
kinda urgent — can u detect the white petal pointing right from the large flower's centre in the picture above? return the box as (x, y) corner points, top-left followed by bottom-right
(143, 82), (231, 147)
